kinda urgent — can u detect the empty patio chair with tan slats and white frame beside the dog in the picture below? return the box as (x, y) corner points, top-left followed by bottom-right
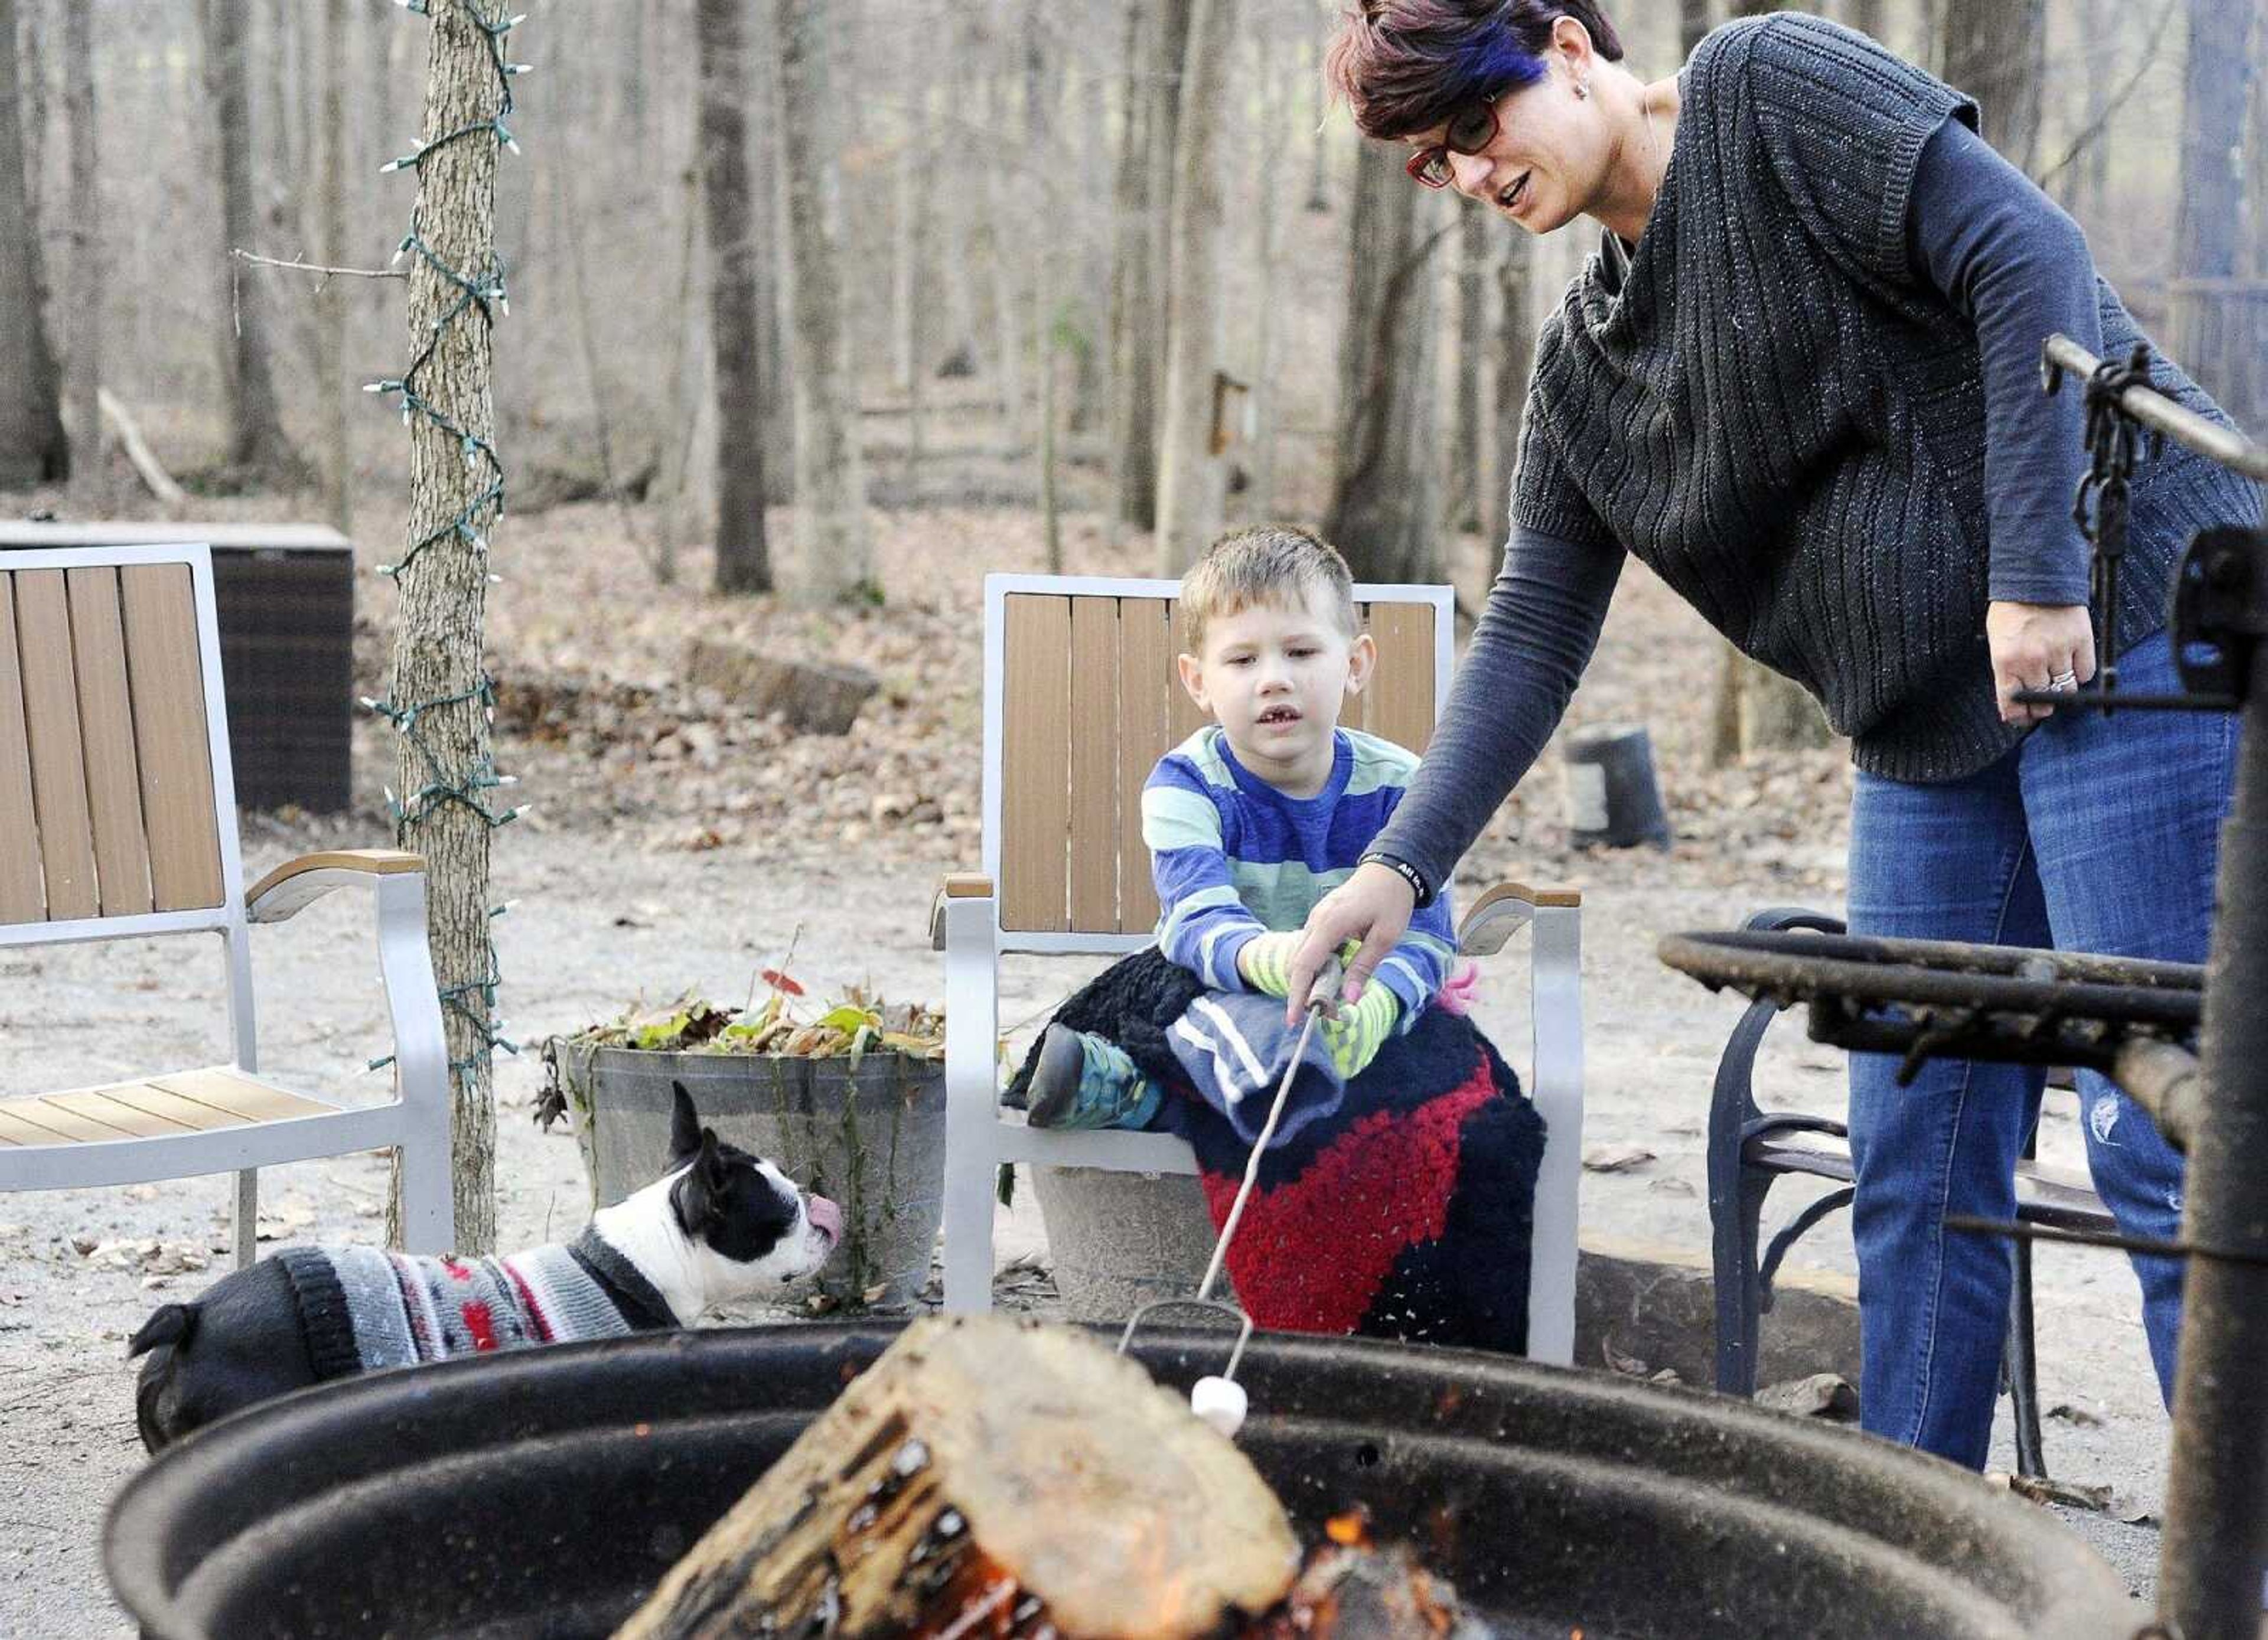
(0, 547), (454, 1266)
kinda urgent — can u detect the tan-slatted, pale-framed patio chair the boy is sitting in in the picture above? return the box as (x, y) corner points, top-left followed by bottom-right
(932, 574), (1583, 1361)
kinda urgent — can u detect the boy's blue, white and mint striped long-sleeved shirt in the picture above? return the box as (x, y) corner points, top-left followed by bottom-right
(1141, 723), (1456, 1030)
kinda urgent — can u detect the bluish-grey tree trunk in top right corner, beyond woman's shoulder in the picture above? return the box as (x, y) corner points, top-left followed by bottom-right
(2168, 0), (2263, 426)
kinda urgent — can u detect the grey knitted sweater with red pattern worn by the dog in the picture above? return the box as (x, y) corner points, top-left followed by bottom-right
(276, 1230), (673, 1379)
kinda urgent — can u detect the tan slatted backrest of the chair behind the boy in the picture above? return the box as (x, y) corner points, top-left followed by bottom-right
(985, 576), (1452, 950)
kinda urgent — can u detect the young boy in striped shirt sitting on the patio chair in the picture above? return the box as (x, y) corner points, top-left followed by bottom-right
(1028, 526), (1456, 1141)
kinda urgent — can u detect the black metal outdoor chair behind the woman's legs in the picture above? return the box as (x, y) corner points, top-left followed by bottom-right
(1708, 907), (2119, 1476)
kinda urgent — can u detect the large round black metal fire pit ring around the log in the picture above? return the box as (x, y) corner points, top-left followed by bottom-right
(105, 1322), (2146, 1640)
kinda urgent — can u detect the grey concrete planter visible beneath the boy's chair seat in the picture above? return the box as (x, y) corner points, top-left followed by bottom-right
(1032, 1168), (1234, 1325)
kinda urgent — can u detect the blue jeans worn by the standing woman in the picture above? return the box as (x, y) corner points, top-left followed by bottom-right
(1849, 633), (2238, 1470)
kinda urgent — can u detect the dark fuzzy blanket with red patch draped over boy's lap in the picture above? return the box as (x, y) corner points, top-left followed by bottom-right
(1012, 946), (1544, 1354)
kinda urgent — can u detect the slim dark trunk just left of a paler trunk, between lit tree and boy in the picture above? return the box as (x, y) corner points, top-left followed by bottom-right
(694, 0), (771, 592)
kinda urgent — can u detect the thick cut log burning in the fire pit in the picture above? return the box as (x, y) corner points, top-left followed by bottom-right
(617, 1316), (1299, 1640)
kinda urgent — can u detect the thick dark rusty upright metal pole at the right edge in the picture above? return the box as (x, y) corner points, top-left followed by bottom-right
(2157, 694), (2268, 1640)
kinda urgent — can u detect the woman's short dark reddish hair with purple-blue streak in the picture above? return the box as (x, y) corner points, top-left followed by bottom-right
(1325, 0), (1622, 136)
